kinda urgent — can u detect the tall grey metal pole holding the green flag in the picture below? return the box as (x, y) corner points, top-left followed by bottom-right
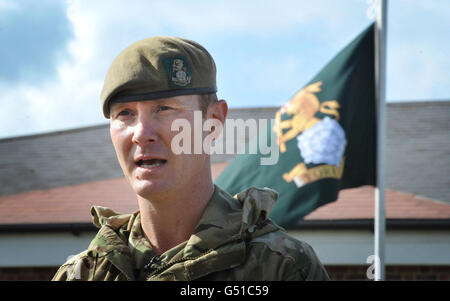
(374, 0), (387, 281)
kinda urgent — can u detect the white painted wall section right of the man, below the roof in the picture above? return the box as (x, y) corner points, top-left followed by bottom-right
(289, 230), (450, 265)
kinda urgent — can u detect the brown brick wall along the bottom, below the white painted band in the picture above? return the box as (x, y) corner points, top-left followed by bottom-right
(0, 266), (450, 281)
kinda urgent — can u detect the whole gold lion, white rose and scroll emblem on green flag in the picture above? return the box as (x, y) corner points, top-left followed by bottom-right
(273, 81), (346, 187)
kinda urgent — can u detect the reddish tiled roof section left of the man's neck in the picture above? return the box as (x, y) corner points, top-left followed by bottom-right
(0, 178), (137, 224)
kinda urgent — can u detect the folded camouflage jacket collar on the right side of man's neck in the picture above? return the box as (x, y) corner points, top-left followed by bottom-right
(149, 186), (279, 280)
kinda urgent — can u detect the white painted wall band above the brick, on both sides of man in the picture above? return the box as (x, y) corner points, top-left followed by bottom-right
(0, 230), (450, 267)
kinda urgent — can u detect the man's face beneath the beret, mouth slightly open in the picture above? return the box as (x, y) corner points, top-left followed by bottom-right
(110, 95), (210, 198)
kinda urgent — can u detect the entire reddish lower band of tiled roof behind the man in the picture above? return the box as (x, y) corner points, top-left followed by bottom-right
(0, 163), (450, 225)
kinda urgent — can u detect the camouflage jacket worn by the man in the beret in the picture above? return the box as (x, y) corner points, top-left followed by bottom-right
(53, 186), (329, 281)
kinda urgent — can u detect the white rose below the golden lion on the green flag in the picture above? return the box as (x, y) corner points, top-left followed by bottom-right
(297, 117), (346, 166)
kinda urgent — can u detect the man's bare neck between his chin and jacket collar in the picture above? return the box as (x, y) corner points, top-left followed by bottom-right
(138, 180), (214, 254)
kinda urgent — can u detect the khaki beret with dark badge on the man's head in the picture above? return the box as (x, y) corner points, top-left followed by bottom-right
(101, 37), (217, 118)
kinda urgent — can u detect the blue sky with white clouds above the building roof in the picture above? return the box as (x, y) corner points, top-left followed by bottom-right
(0, 0), (450, 138)
